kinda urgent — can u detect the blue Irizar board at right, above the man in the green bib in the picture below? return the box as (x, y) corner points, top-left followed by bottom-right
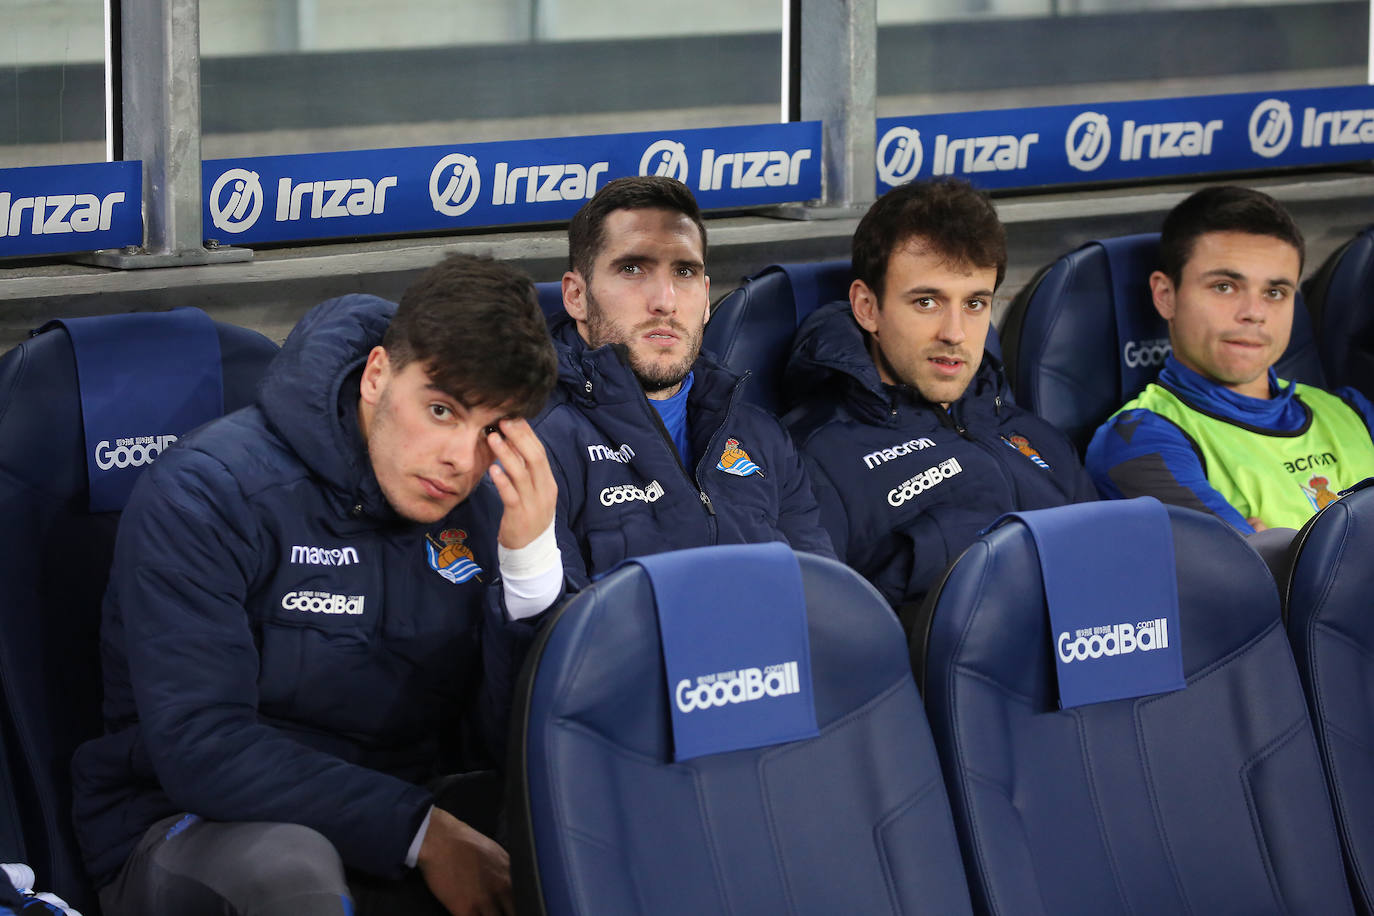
(875, 85), (1374, 194)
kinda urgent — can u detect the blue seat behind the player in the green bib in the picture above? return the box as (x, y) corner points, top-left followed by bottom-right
(1002, 232), (1326, 453)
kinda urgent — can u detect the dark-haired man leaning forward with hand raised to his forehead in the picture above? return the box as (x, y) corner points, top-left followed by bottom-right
(73, 257), (563, 916)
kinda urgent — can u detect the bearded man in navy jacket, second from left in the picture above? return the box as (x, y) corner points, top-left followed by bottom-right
(534, 176), (834, 586)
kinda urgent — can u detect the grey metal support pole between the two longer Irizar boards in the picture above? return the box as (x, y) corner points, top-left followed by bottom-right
(779, 0), (878, 220)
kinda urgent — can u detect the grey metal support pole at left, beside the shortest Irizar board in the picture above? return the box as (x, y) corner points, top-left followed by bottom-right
(89, 0), (253, 269)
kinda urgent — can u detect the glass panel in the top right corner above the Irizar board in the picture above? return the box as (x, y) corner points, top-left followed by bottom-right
(878, 0), (1370, 115)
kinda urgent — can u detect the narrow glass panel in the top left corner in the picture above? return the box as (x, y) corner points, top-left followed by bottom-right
(0, 0), (106, 168)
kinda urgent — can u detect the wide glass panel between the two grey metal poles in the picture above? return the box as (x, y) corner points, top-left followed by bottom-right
(201, 0), (782, 159)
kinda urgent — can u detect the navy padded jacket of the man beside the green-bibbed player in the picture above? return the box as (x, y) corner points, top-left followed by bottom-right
(783, 301), (1096, 607)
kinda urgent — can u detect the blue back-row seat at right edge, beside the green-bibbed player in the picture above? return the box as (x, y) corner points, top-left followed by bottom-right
(1303, 225), (1374, 398)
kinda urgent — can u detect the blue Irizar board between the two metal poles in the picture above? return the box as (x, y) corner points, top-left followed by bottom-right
(202, 121), (820, 243)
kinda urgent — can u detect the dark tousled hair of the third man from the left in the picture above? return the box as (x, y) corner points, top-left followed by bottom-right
(851, 179), (1007, 302)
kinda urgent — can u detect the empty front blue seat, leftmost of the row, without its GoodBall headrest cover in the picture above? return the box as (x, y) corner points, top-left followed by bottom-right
(508, 548), (970, 916)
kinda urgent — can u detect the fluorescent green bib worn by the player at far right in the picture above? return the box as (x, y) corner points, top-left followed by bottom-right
(1123, 382), (1374, 527)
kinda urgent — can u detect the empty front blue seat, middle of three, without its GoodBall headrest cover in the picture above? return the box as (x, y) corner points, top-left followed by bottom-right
(912, 503), (1353, 916)
